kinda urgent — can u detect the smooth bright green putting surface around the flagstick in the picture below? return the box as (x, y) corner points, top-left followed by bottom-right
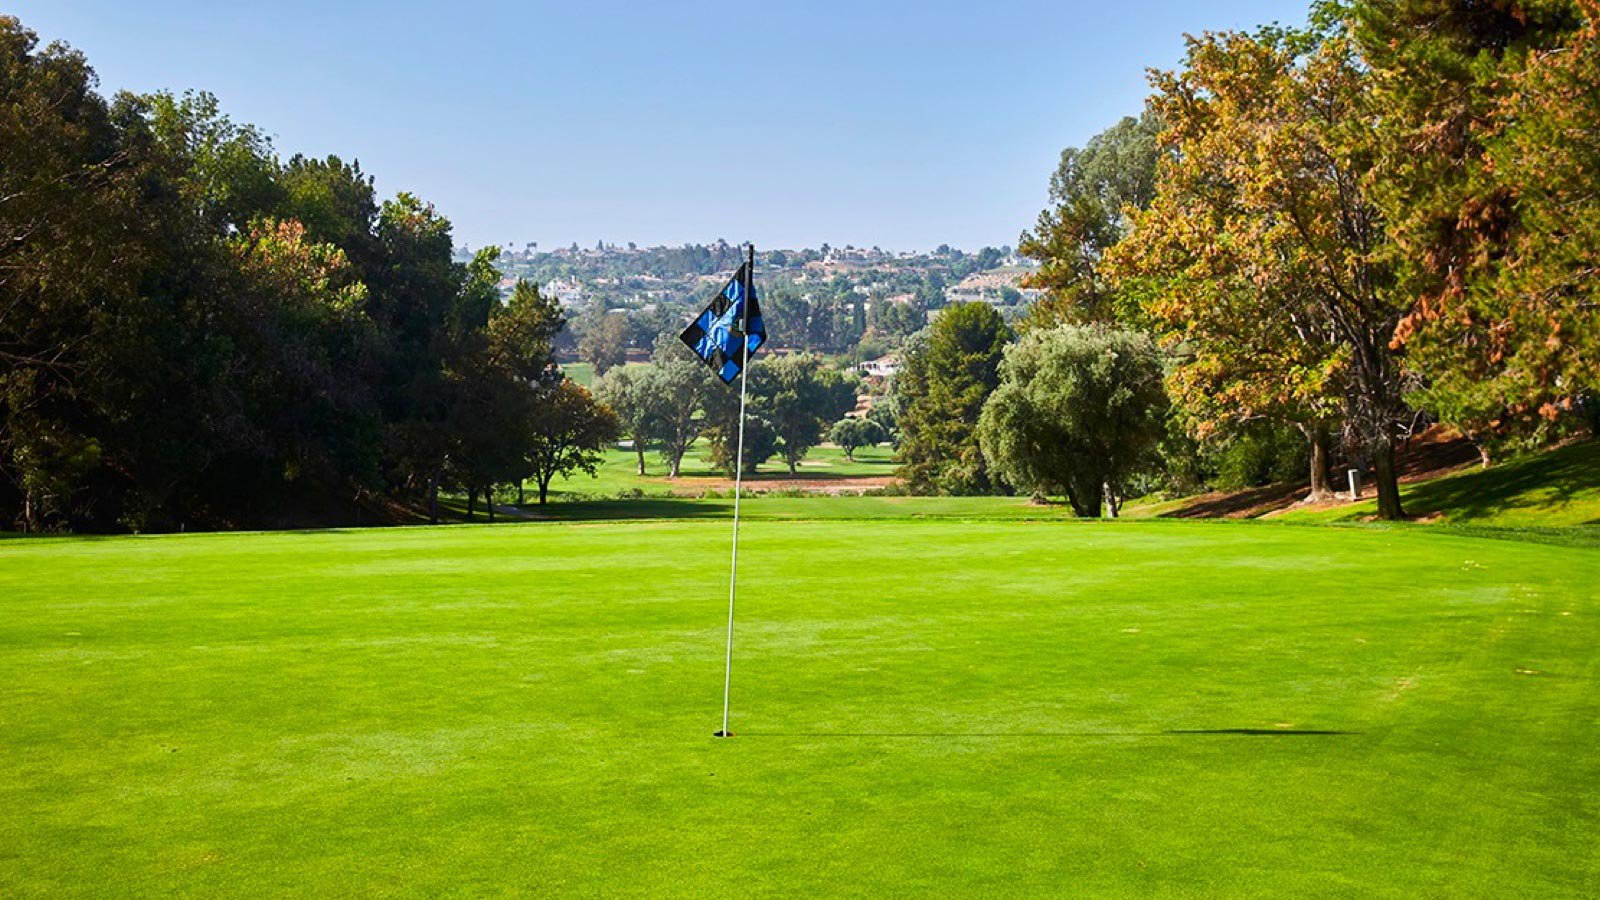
(0, 515), (1600, 898)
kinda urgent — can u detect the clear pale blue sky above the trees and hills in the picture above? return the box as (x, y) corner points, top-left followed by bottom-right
(6, 0), (1306, 250)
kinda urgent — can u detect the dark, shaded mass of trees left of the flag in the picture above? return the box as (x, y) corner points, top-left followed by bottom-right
(0, 18), (619, 530)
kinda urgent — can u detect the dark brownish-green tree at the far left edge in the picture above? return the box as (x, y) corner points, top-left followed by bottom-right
(0, 16), (147, 528)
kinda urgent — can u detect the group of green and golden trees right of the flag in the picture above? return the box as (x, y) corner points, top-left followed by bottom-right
(896, 0), (1600, 519)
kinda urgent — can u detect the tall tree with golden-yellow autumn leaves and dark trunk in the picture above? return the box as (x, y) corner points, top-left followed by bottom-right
(1110, 22), (1410, 519)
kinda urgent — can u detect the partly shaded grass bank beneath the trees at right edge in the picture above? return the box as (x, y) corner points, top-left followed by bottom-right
(1283, 440), (1600, 527)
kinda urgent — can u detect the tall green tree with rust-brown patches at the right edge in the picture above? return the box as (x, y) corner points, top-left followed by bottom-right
(1352, 0), (1600, 464)
